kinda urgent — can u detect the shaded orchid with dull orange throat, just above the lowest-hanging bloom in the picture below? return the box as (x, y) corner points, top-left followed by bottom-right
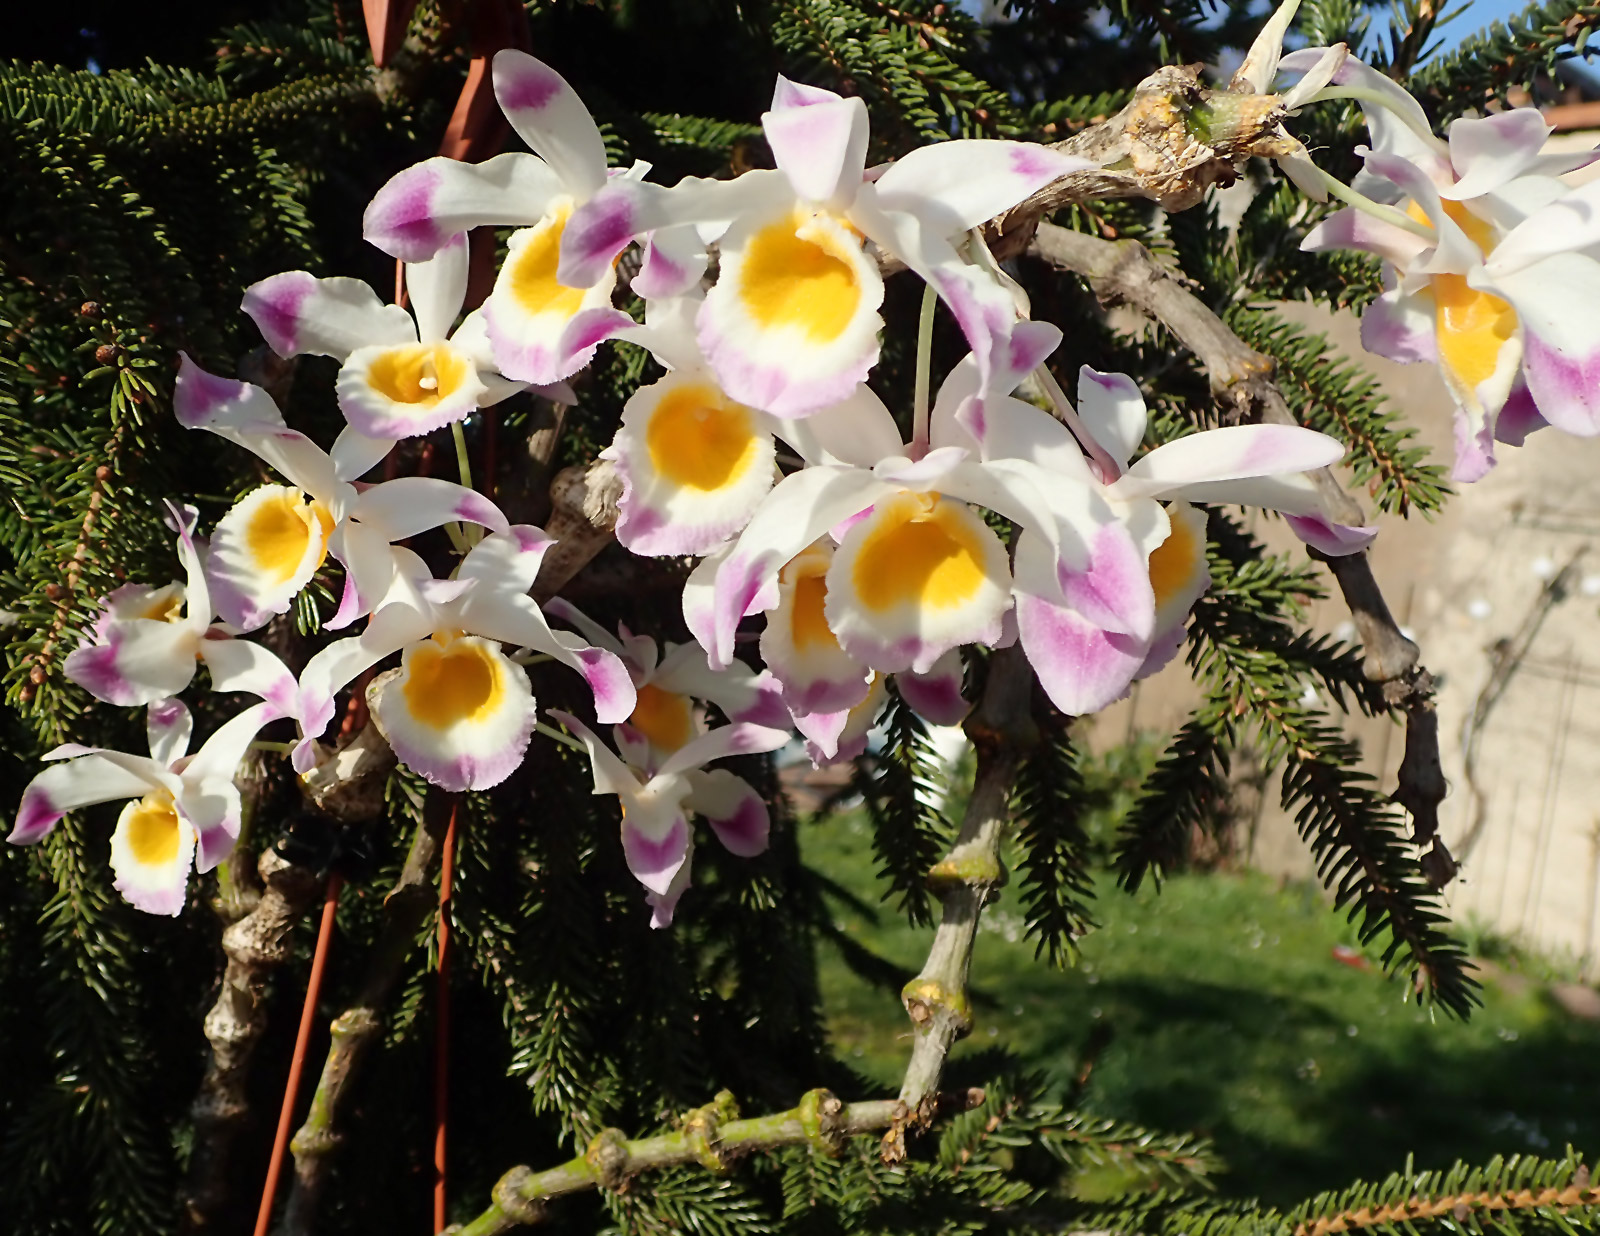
(544, 597), (789, 773)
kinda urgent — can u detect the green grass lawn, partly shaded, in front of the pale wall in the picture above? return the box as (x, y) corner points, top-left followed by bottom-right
(802, 812), (1600, 1204)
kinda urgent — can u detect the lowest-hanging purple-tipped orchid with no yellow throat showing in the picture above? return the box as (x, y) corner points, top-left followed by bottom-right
(550, 711), (789, 927)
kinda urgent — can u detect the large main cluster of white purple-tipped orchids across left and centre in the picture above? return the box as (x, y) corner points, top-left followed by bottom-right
(10, 43), (1382, 924)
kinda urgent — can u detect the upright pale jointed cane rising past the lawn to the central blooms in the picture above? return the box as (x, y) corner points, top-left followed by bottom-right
(883, 645), (1038, 1133)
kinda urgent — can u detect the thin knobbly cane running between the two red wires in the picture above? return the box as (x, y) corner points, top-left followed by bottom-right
(277, 793), (450, 1236)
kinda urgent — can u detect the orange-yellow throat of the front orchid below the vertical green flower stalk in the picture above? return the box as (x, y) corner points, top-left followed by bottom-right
(851, 493), (989, 612)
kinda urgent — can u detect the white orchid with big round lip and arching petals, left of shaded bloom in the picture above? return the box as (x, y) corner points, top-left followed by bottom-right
(294, 524), (637, 791)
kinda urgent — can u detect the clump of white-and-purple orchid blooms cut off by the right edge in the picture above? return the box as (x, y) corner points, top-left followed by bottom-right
(1282, 50), (1600, 482)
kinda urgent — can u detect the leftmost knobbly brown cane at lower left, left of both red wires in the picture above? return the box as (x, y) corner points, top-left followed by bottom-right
(178, 849), (322, 1233)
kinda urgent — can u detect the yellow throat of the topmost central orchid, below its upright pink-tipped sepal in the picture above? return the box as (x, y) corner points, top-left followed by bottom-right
(739, 213), (861, 343)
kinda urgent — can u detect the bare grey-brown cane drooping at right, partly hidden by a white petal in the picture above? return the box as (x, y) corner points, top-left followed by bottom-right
(1029, 224), (1454, 858)
